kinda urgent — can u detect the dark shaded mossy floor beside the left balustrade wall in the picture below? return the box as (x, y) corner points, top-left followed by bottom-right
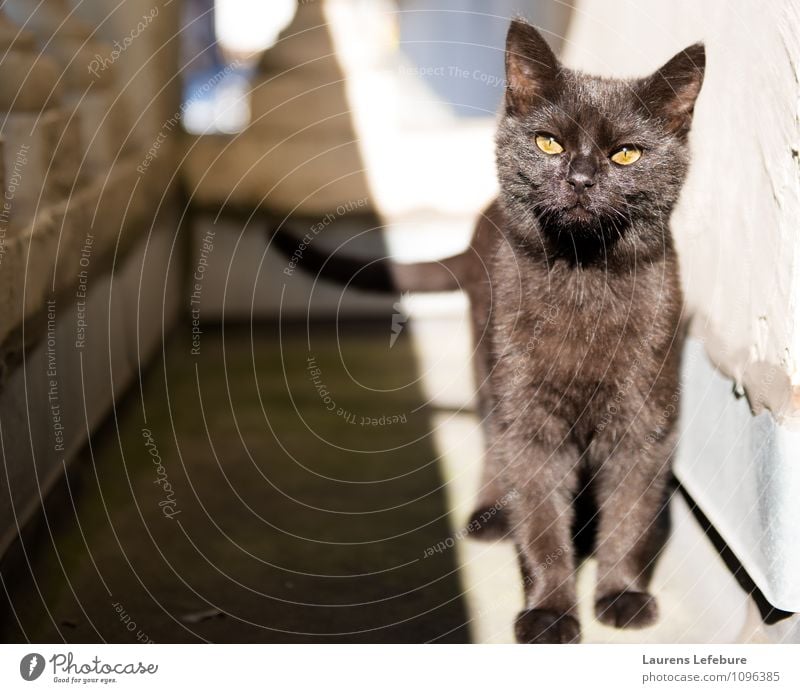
(0, 319), (469, 643)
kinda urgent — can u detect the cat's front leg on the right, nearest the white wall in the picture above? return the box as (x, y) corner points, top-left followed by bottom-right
(595, 434), (675, 628)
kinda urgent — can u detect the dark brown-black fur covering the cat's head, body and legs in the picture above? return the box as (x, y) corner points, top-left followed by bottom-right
(272, 21), (705, 642)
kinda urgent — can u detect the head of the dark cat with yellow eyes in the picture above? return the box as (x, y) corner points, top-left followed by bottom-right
(497, 21), (705, 250)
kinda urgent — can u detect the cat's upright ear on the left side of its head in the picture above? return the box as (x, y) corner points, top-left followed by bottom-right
(506, 19), (559, 115)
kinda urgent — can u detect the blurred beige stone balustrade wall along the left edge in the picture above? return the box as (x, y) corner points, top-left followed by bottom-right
(0, 0), (180, 554)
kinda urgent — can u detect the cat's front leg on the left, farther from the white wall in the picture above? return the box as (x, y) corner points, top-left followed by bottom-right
(507, 443), (580, 643)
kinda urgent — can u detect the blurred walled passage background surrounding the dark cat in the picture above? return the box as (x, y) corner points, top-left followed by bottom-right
(0, 0), (800, 643)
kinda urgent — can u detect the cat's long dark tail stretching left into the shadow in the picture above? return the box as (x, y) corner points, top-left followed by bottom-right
(267, 225), (468, 293)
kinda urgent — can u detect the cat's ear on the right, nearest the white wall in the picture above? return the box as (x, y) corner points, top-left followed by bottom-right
(638, 43), (706, 135)
